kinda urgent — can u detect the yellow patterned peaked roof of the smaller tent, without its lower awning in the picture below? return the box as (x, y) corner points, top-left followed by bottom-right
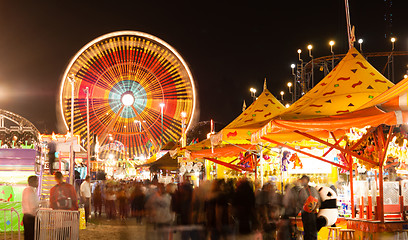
(214, 88), (285, 143)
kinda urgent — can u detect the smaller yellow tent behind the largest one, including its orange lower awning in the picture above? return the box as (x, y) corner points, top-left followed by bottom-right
(175, 86), (285, 174)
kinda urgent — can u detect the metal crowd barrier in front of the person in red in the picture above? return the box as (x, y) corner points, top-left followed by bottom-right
(34, 209), (79, 240)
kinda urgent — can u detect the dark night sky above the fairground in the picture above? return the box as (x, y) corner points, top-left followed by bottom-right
(0, 0), (408, 133)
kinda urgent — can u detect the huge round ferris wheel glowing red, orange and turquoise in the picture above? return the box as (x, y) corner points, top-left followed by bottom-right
(60, 31), (196, 158)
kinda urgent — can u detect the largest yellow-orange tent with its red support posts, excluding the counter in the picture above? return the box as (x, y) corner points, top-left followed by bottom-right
(252, 48), (408, 223)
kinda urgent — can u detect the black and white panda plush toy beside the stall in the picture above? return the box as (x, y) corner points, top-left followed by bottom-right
(316, 187), (339, 231)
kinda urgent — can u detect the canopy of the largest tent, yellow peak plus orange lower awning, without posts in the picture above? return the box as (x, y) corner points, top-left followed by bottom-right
(251, 48), (402, 166)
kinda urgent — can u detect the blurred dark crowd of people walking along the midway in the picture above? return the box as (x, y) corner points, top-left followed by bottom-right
(85, 176), (319, 239)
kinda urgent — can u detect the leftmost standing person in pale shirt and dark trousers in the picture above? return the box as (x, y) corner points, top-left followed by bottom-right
(21, 175), (40, 240)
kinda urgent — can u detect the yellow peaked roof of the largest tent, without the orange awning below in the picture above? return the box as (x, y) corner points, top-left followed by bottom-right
(279, 48), (393, 119)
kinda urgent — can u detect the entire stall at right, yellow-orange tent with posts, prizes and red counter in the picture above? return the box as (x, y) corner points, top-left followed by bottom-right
(252, 48), (408, 236)
